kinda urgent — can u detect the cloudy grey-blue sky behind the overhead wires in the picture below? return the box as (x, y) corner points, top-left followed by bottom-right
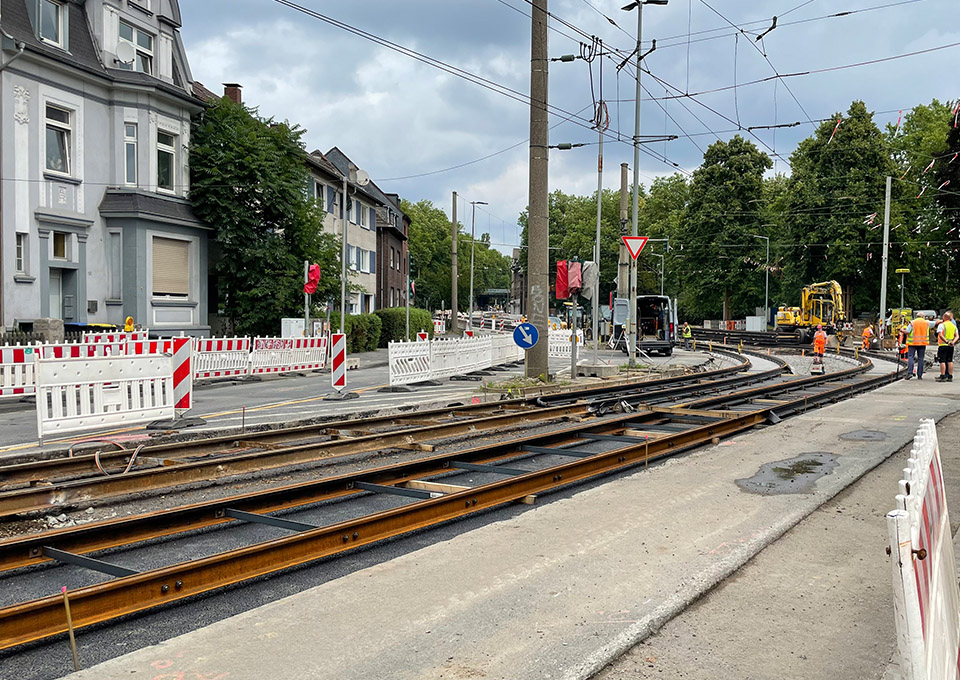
(180, 0), (960, 252)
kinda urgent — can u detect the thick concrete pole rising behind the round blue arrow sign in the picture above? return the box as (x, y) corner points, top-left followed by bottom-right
(524, 0), (550, 379)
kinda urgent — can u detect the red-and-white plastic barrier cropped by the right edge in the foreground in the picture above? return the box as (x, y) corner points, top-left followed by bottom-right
(887, 420), (960, 680)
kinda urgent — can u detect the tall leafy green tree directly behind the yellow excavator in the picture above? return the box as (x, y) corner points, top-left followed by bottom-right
(787, 101), (894, 312)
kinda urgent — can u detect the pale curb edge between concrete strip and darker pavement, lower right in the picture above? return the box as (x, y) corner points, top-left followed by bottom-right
(560, 408), (936, 680)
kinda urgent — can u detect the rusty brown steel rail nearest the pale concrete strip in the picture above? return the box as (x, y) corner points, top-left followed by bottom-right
(0, 366), (896, 649)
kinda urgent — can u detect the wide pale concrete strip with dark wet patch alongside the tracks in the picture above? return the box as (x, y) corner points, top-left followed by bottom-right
(62, 381), (960, 680)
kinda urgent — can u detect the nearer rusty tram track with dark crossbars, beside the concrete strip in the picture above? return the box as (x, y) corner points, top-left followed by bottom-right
(0, 350), (896, 648)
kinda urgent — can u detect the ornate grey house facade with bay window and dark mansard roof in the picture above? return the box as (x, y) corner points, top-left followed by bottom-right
(0, 0), (209, 335)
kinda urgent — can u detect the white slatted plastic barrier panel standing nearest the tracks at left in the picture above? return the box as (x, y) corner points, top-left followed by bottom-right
(35, 354), (175, 444)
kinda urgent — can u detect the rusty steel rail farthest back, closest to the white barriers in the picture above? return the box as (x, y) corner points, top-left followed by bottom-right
(0, 352), (750, 489)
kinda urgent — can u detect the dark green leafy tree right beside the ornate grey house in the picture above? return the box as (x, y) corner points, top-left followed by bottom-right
(190, 98), (340, 335)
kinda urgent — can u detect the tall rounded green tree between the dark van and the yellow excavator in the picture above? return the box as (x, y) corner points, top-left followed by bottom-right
(679, 135), (773, 318)
